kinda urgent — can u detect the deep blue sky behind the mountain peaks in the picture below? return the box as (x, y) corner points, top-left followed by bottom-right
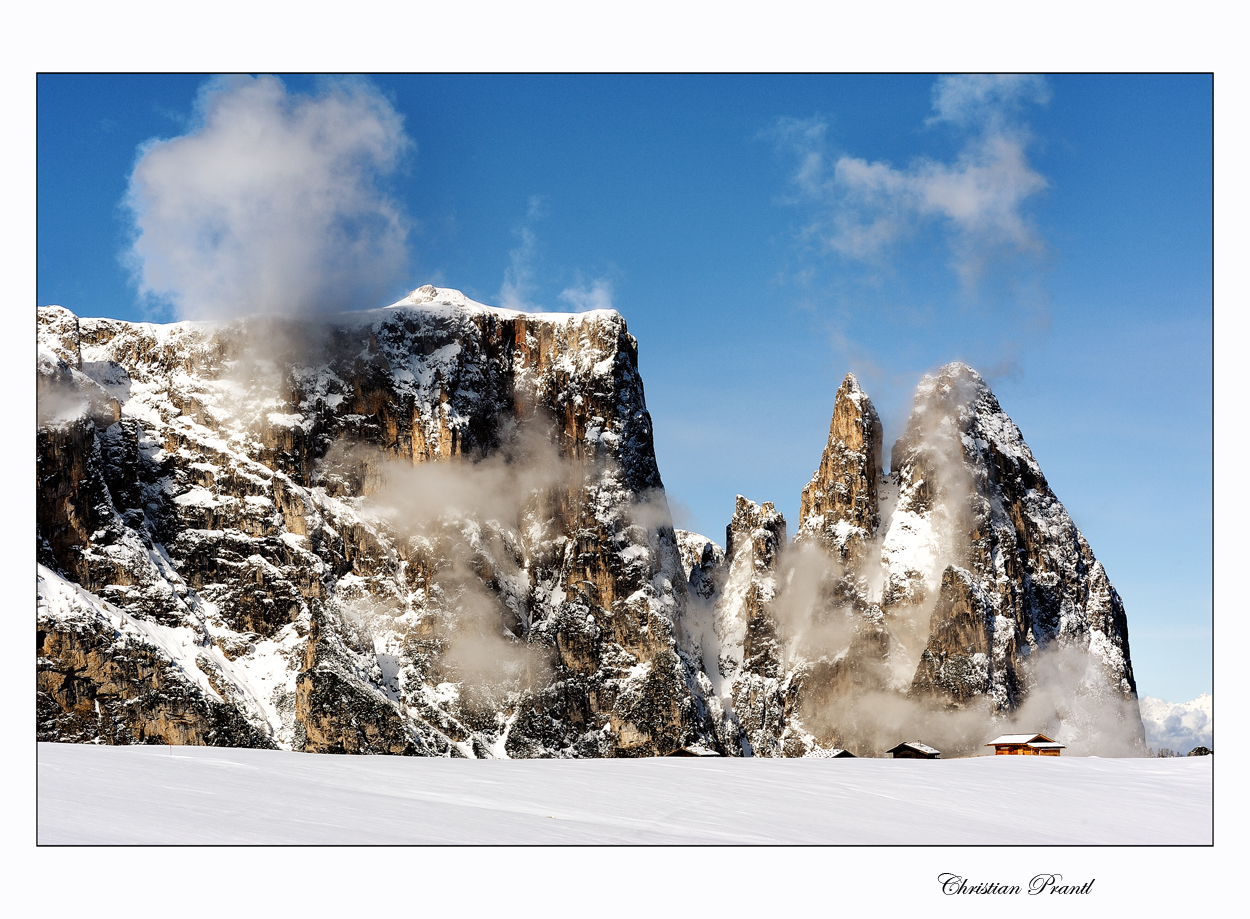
(38, 76), (1213, 700)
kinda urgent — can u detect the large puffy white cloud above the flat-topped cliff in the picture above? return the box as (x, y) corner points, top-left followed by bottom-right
(126, 76), (414, 318)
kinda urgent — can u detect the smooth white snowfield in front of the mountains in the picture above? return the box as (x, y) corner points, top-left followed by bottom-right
(38, 744), (1214, 845)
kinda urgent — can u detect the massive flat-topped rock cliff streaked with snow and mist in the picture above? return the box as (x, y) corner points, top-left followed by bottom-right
(36, 288), (711, 756)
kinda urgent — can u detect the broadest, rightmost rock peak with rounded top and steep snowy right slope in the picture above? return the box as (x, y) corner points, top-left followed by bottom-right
(895, 364), (1140, 720)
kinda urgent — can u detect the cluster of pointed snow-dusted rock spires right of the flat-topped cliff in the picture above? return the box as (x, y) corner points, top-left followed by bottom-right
(679, 364), (1145, 755)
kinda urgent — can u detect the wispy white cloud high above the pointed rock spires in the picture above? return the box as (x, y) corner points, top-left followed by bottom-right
(778, 75), (1049, 286)
